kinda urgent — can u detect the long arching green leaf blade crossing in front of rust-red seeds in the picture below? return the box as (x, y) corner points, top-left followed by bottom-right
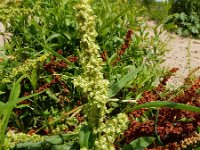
(131, 101), (200, 113)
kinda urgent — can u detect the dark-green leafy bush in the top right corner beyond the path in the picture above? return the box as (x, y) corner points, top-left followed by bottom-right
(167, 0), (200, 38)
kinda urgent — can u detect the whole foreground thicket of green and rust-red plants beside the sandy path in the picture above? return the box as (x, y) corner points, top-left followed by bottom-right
(0, 0), (200, 150)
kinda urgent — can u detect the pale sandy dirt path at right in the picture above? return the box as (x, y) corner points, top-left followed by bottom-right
(163, 34), (200, 86)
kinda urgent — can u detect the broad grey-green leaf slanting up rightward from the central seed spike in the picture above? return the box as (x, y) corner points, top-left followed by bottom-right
(108, 65), (143, 98)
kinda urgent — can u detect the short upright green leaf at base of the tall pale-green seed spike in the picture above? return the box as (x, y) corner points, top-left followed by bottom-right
(79, 125), (92, 148)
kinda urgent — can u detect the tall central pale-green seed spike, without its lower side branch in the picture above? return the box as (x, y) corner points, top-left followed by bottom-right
(73, 0), (109, 128)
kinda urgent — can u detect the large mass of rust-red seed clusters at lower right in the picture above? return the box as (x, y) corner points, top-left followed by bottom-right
(124, 69), (200, 150)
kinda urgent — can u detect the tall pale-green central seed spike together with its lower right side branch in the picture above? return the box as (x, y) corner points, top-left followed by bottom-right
(73, 0), (128, 150)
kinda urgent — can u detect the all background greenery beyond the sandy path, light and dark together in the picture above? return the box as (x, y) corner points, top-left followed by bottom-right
(141, 0), (200, 38)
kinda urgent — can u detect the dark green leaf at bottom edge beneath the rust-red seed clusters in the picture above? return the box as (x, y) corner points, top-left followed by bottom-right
(122, 136), (155, 150)
